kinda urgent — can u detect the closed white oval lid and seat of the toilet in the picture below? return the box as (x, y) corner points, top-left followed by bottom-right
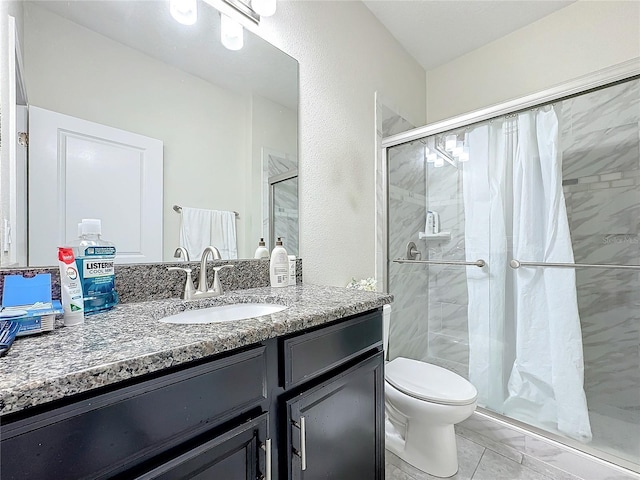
(385, 357), (478, 405)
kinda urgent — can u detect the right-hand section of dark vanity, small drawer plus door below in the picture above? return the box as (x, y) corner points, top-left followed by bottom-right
(281, 313), (384, 480)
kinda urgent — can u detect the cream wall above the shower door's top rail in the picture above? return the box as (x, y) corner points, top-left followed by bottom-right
(427, 0), (640, 123)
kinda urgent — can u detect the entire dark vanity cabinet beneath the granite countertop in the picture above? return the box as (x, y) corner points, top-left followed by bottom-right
(0, 310), (384, 480)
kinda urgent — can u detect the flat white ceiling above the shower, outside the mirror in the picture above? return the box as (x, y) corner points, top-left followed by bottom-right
(363, 0), (575, 70)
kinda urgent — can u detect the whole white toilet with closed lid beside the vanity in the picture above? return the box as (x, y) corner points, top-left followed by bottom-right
(383, 305), (478, 477)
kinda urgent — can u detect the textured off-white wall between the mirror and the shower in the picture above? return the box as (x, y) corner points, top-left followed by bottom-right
(258, 0), (426, 285)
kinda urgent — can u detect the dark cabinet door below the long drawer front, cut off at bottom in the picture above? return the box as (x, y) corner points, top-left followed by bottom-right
(136, 413), (271, 480)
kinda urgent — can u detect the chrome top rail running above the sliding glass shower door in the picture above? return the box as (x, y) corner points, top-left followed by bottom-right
(382, 58), (640, 148)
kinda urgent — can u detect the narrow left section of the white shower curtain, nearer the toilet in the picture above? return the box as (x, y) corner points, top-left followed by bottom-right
(462, 123), (508, 412)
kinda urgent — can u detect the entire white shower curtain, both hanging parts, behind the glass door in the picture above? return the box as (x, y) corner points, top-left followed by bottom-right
(463, 107), (591, 442)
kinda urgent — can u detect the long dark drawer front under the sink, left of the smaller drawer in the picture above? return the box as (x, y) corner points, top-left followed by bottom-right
(0, 347), (267, 480)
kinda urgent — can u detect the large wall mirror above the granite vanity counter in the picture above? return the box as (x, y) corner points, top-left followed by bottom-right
(0, 0), (299, 266)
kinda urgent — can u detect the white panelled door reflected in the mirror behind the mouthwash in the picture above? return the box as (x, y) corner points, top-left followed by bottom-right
(28, 106), (163, 266)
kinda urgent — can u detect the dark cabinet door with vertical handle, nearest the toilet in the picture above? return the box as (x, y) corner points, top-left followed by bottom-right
(287, 352), (384, 480)
